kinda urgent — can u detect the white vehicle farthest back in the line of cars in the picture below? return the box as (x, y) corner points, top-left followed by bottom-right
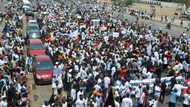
(22, 0), (33, 16)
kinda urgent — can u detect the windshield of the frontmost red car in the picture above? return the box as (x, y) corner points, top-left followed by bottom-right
(36, 61), (53, 70)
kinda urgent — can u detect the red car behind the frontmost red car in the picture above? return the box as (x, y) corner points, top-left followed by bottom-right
(27, 39), (46, 56)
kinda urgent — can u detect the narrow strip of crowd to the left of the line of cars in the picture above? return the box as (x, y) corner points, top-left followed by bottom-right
(0, 0), (29, 107)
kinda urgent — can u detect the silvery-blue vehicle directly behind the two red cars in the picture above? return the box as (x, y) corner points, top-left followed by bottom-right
(26, 21), (41, 39)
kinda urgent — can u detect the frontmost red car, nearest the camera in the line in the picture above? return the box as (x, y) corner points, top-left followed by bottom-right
(32, 55), (53, 84)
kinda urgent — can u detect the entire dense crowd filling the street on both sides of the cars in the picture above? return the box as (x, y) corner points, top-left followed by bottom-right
(0, 0), (190, 107)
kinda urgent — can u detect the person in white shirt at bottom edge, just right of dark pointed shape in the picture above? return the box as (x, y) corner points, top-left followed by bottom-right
(121, 94), (133, 107)
